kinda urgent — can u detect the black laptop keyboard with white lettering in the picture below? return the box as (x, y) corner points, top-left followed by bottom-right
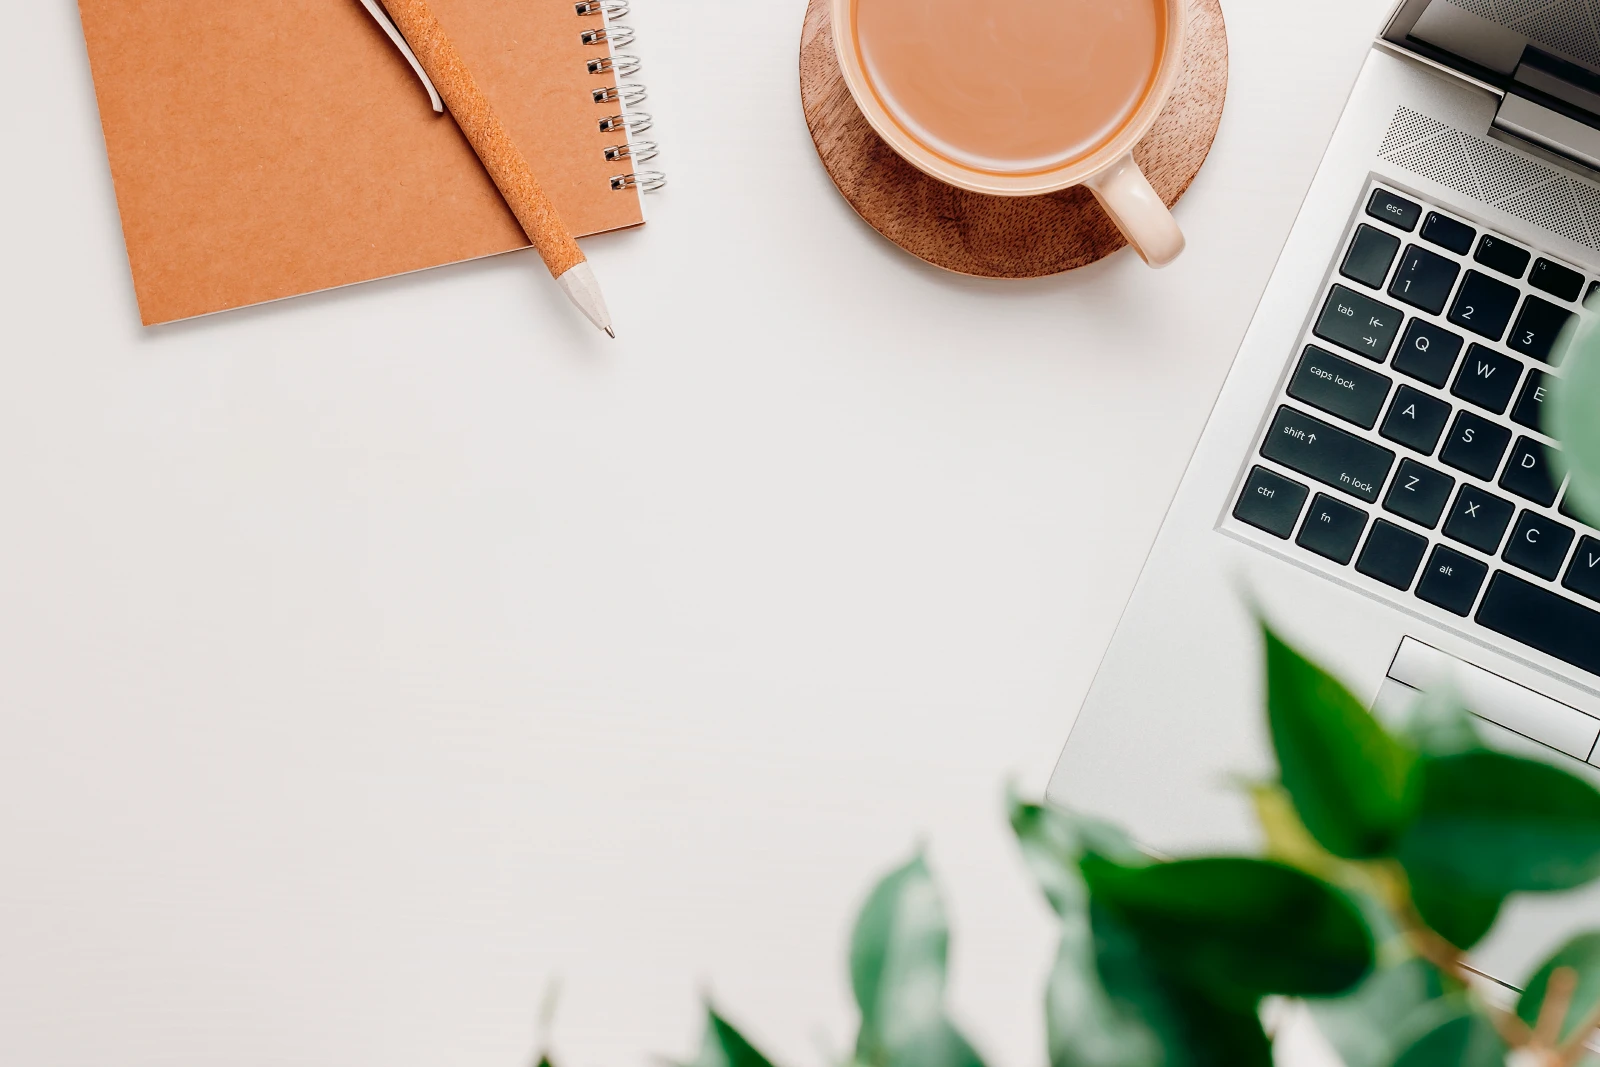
(1232, 186), (1600, 675)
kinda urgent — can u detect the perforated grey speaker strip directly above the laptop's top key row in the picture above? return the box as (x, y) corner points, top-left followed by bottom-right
(1378, 107), (1600, 251)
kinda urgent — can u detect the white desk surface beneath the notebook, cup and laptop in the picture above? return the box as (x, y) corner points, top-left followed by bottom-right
(0, 0), (1387, 1067)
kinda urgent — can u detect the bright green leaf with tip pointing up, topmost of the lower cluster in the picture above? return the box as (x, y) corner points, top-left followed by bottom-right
(1262, 625), (1416, 859)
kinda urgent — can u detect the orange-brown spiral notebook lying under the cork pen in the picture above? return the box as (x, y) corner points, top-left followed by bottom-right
(78, 0), (656, 325)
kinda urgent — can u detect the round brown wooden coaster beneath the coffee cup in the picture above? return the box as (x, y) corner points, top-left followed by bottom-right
(800, 0), (1227, 278)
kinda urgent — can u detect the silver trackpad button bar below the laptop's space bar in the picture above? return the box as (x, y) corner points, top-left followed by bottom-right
(1378, 637), (1600, 779)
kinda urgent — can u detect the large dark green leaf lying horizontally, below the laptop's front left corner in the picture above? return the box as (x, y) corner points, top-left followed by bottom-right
(1083, 856), (1374, 1008)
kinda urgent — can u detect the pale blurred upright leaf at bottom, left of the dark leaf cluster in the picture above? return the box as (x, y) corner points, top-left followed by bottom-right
(850, 856), (982, 1067)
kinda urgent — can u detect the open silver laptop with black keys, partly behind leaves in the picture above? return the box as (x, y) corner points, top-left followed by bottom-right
(1050, 0), (1600, 982)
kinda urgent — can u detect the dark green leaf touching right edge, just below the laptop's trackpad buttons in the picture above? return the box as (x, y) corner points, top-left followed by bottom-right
(1400, 752), (1600, 899)
